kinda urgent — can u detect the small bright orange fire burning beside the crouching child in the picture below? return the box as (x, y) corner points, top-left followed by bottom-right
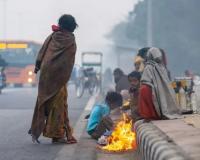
(102, 114), (136, 152)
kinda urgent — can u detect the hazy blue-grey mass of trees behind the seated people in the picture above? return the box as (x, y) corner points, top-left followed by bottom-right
(110, 0), (200, 77)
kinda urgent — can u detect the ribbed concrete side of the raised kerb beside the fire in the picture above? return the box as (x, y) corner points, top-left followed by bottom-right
(134, 120), (191, 160)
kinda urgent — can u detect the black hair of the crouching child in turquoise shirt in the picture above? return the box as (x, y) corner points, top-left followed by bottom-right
(105, 91), (123, 107)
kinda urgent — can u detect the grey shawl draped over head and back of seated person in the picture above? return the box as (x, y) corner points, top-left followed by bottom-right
(141, 48), (179, 119)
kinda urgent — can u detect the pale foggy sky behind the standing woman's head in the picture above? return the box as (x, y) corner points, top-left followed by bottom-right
(0, 0), (138, 63)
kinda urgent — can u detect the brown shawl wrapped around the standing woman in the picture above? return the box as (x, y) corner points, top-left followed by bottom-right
(36, 31), (76, 106)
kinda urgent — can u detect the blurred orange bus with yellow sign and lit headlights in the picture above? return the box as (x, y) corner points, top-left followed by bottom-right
(0, 41), (41, 86)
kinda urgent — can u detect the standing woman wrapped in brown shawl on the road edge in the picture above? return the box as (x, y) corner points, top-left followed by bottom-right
(30, 14), (77, 143)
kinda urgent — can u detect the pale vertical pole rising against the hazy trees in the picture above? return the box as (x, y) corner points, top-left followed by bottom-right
(147, 0), (153, 47)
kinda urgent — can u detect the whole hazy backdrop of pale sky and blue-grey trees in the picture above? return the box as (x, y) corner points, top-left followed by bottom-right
(0, 0), (200, 76)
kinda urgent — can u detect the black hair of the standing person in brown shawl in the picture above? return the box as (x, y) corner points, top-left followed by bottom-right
(58, 14), (78, 32)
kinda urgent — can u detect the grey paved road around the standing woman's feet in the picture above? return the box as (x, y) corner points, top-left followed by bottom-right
(0, 87), (89, 160)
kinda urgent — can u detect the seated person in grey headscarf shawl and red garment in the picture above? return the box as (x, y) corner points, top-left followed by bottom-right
(139, 48), (179, 120)
